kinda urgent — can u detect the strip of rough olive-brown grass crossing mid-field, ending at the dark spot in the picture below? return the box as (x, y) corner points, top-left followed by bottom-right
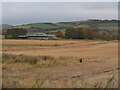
(2, 53), (83, 67)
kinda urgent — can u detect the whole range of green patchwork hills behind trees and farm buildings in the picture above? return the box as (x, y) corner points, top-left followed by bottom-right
(2, 19), (118, 33)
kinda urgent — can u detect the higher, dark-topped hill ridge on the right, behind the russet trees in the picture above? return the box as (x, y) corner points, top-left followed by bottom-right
(58, 19), (119, 33)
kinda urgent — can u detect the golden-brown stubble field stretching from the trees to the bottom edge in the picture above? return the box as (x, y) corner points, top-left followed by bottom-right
(2, 40), (118, 88)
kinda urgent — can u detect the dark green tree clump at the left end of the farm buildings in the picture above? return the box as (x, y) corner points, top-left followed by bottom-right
(5, 28), (27, 39)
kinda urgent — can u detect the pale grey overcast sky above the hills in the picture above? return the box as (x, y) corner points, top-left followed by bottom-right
(2, 2), (118, 25)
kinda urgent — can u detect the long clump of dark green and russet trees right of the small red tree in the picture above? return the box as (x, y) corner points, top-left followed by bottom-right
(65, 27), (118, 40)
